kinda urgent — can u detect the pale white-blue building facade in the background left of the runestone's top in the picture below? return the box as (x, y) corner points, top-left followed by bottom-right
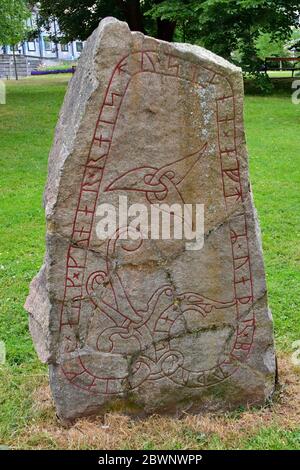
(0, 9), (84, 61)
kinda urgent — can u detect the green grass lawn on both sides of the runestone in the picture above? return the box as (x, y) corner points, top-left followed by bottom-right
(0, 76), (300, 449)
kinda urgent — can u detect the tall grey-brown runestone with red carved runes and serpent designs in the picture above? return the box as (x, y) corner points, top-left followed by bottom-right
(26, 18), (275, 420)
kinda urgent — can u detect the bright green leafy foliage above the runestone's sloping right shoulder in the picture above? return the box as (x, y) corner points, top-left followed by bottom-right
(148, 0), (300, 73)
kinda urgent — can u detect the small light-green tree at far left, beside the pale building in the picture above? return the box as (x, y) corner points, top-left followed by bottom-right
(0, 0), (30, 80)
